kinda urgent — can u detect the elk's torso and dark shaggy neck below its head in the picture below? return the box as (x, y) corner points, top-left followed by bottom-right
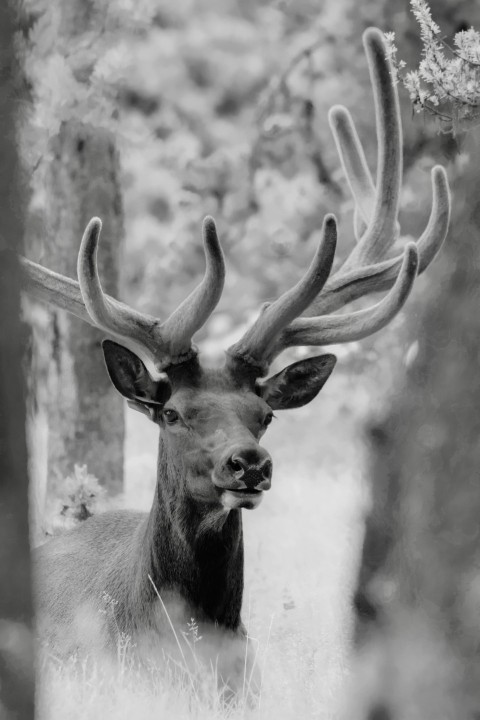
(36, 510), (243, 656)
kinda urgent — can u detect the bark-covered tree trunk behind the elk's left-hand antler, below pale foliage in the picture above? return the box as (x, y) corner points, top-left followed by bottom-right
(42, 122), (124, 493)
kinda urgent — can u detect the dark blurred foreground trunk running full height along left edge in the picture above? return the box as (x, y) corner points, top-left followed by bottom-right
(0, 2), (34, 720)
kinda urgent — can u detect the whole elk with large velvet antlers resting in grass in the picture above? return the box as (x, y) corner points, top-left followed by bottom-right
(22, 29), (450, 688)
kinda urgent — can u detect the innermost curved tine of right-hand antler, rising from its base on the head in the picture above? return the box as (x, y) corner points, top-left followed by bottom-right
(227, 215), (337, 372)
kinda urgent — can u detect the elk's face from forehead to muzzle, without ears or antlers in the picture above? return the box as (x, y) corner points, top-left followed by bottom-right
(158, 382), (273, 509)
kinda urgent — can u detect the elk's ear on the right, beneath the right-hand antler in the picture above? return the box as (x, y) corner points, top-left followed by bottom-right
(256, 355), (337, 410)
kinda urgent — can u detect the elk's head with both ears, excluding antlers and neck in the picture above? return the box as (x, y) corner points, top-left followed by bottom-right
(103, 340), (335, 510)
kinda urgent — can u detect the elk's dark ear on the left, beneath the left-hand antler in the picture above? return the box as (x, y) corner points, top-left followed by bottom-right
(102, 340), (172, 414)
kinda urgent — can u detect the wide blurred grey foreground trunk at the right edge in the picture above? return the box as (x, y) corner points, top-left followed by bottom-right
(346, 132), (480, 720)
